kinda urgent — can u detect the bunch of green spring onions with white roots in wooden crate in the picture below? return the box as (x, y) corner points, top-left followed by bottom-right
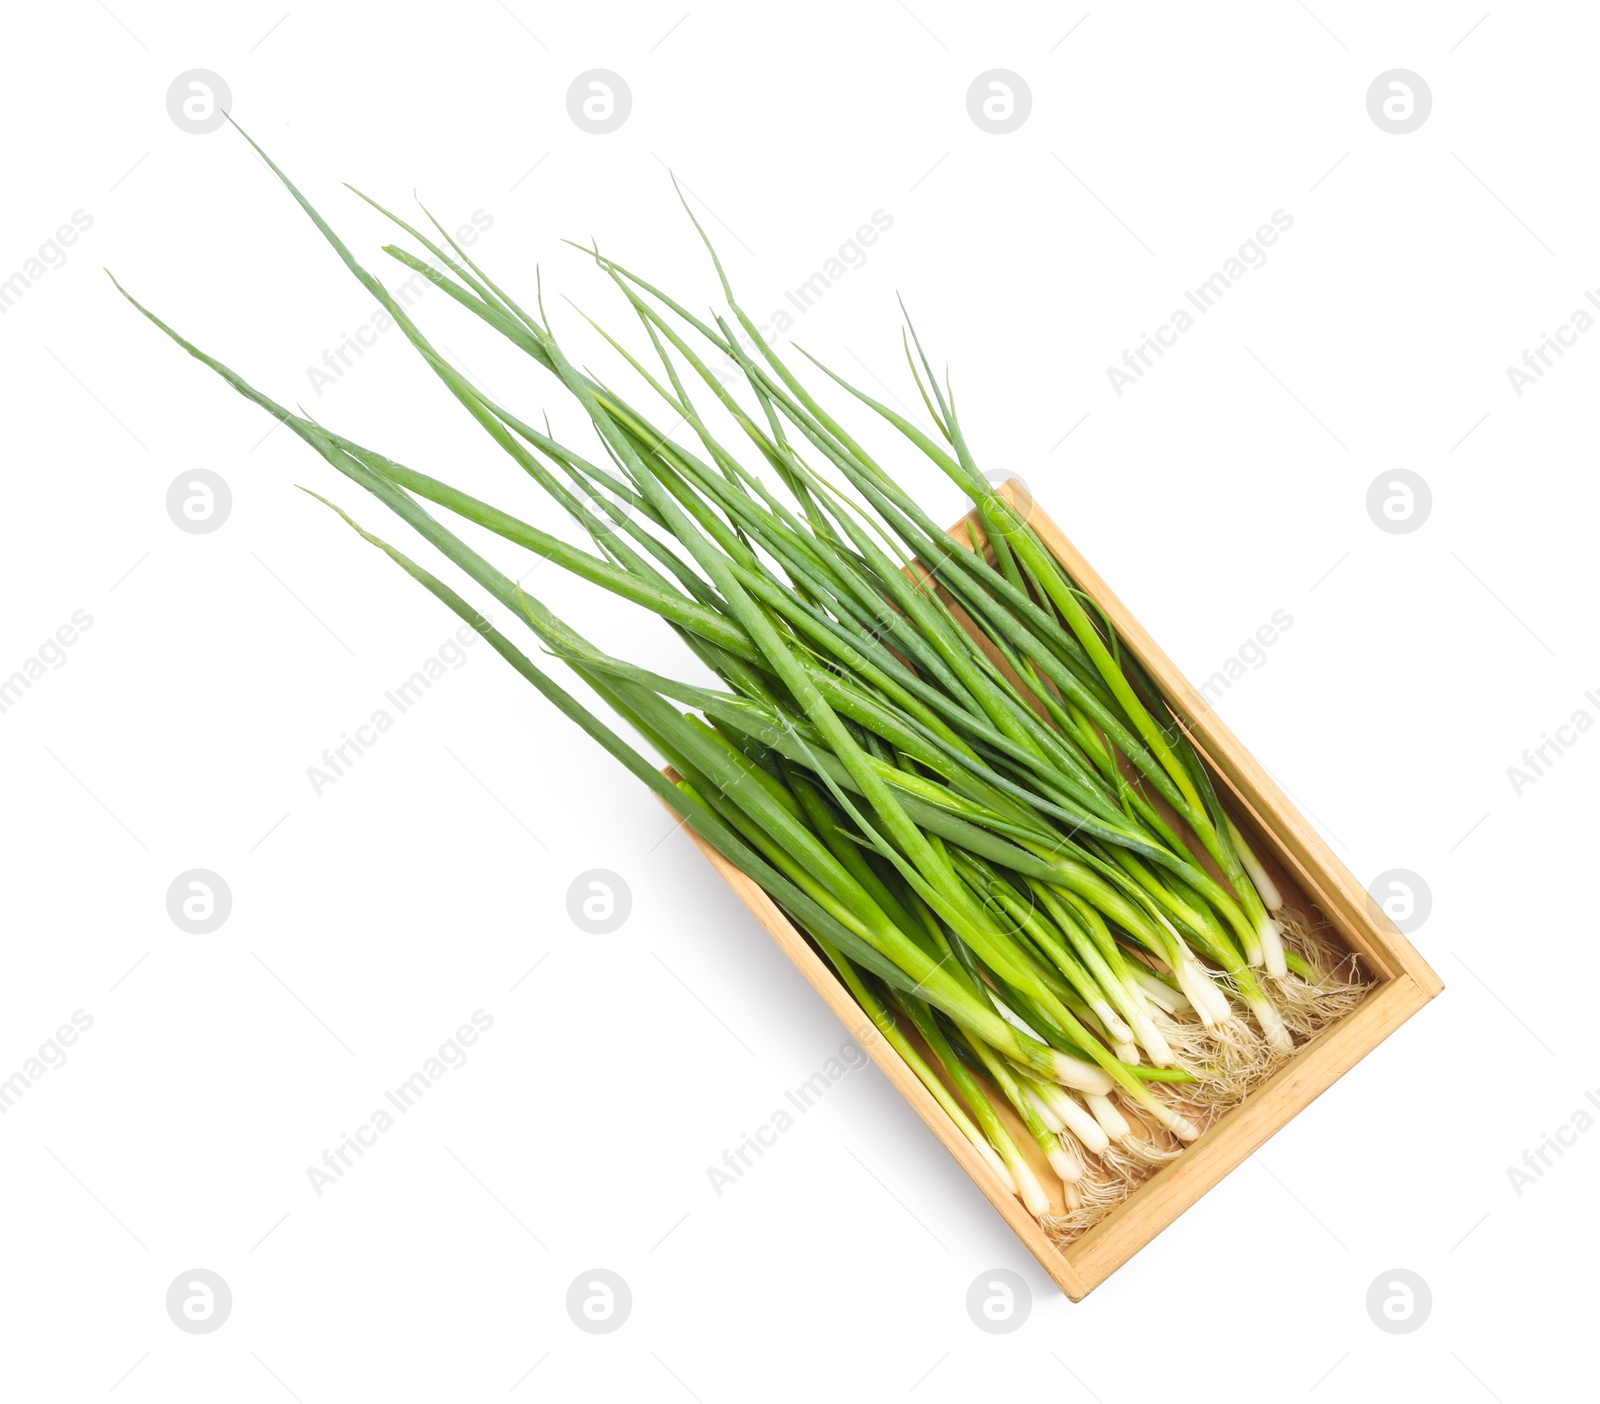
(118, 126), (1360, 1231)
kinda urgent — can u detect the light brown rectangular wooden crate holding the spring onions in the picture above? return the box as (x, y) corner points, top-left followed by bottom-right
(659, 480), (1443, 1302)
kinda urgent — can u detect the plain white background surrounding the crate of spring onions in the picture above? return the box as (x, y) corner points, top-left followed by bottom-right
(0, 0), (1600, 1404)
